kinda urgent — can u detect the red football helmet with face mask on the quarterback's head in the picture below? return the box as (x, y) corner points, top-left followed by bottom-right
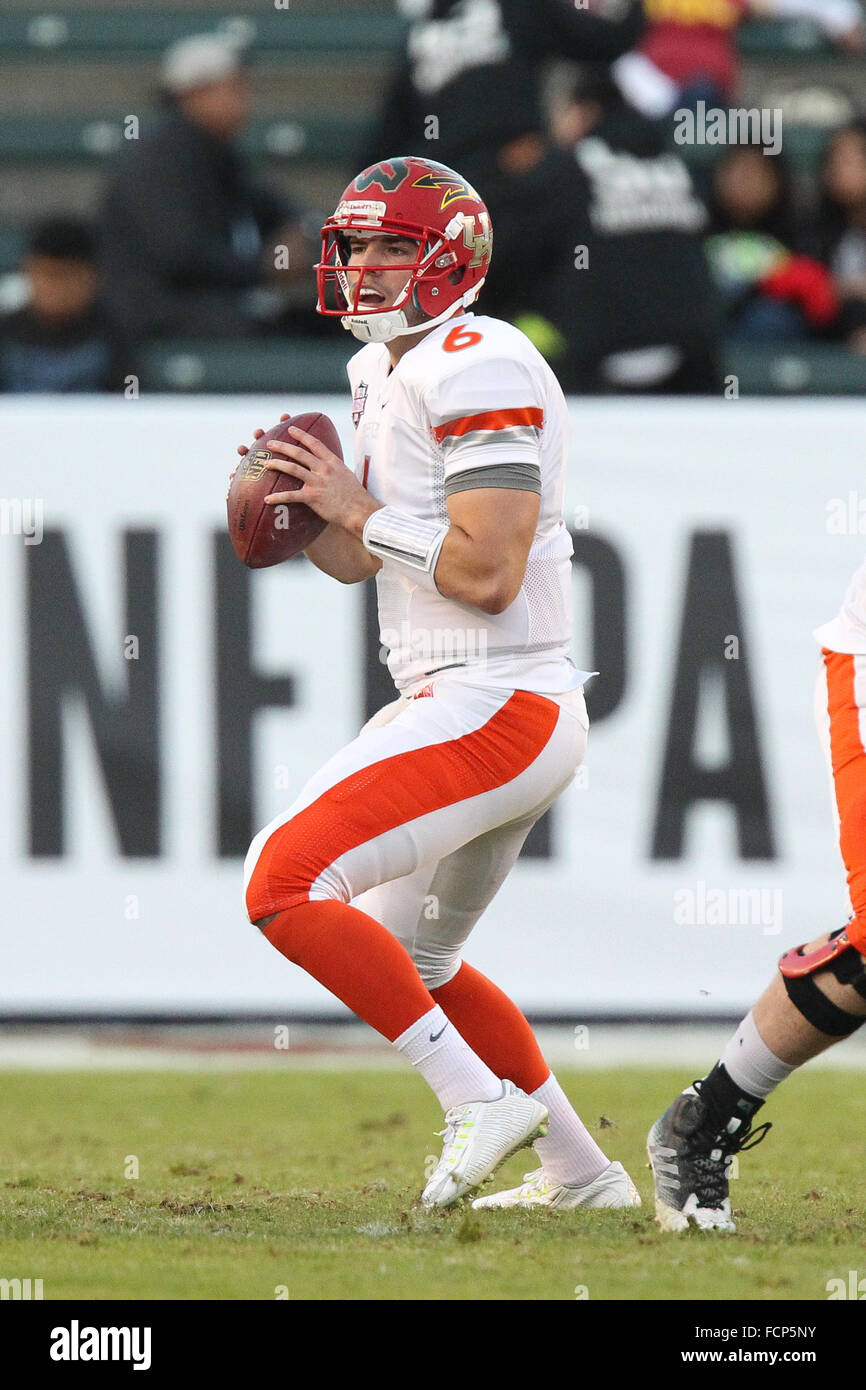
(316, 156), (493, 343)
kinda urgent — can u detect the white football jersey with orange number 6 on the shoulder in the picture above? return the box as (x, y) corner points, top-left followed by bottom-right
(348, 313), (591, 694)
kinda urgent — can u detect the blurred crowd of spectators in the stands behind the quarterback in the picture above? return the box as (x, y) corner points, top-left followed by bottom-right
(0, 0), (866, 393)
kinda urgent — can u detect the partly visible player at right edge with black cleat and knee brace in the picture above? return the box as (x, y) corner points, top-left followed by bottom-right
(646, 562), (866, 1232)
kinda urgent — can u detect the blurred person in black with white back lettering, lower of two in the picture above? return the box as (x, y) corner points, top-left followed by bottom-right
(536, 68), (721, 395)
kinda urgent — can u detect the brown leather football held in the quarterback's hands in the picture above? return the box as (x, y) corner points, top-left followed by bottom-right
(227, 411), (343, 570)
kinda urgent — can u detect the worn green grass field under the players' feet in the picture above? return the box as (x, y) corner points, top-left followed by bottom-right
(0, 1069), (866, 1300)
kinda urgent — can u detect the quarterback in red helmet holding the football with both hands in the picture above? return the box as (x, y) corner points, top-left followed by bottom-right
(245, 157), (639, 1207)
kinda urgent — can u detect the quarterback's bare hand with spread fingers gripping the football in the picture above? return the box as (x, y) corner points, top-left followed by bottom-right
(238, 416), (381, 539)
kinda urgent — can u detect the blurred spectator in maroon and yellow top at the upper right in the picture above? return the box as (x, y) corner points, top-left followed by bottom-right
(614, 0), (863, 117)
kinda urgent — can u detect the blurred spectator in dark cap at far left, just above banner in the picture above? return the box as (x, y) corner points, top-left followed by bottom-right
(0, 217), (129, 392)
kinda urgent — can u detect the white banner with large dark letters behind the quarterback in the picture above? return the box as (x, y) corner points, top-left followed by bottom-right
(0, 396), (866, 1019)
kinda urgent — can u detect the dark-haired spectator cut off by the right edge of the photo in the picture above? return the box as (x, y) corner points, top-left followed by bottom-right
(817, 120), (866, 353)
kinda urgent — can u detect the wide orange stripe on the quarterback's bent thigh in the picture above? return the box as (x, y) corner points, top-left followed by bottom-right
(246, 691), (559, 922)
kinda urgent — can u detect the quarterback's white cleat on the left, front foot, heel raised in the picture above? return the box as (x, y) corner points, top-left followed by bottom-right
(421, 1081), (548, 1207)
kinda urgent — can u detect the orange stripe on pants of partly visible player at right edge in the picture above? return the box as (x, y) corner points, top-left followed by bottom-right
(823, 648), (866, 952)
